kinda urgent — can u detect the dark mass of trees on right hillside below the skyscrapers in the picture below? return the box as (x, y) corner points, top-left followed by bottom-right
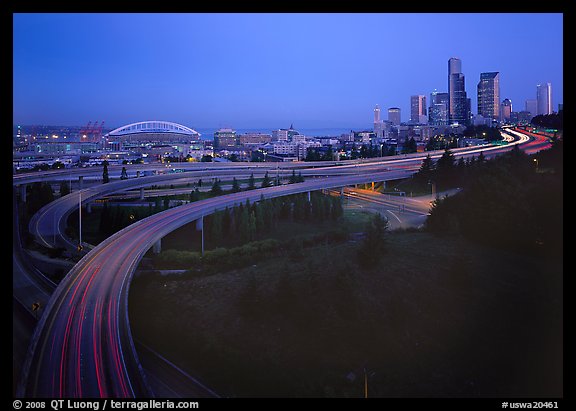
(424, 141), (563, 253)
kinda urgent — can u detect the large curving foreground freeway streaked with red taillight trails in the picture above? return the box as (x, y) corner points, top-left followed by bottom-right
(17, 127), (548, 397)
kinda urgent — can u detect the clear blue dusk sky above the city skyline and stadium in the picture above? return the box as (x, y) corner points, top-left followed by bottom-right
(13, 13), (563, 129)
